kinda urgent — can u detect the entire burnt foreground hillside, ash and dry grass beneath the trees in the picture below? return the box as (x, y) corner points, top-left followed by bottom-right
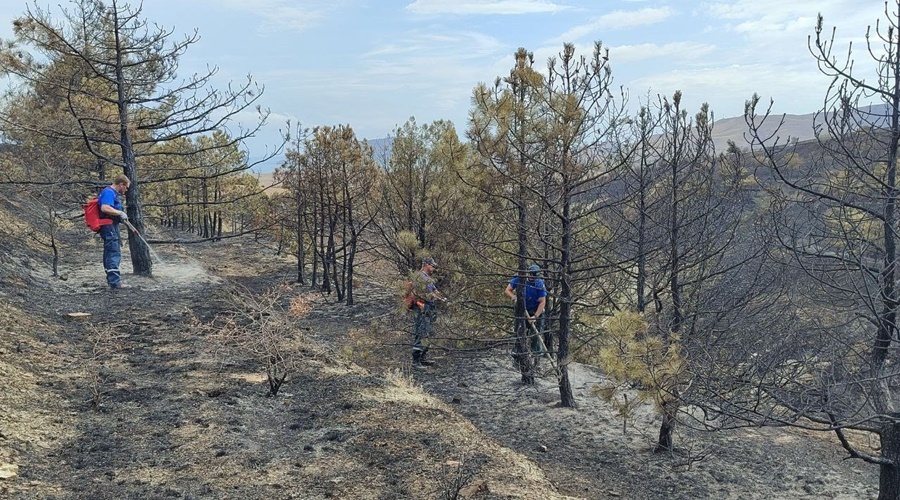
(0, 189), (878, 500)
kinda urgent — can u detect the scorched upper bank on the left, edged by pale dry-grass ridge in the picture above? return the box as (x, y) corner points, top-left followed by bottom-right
(0, 228), (561, 499)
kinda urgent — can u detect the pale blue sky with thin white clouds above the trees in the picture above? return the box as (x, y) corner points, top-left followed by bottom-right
(0, 0), (884, 169)
